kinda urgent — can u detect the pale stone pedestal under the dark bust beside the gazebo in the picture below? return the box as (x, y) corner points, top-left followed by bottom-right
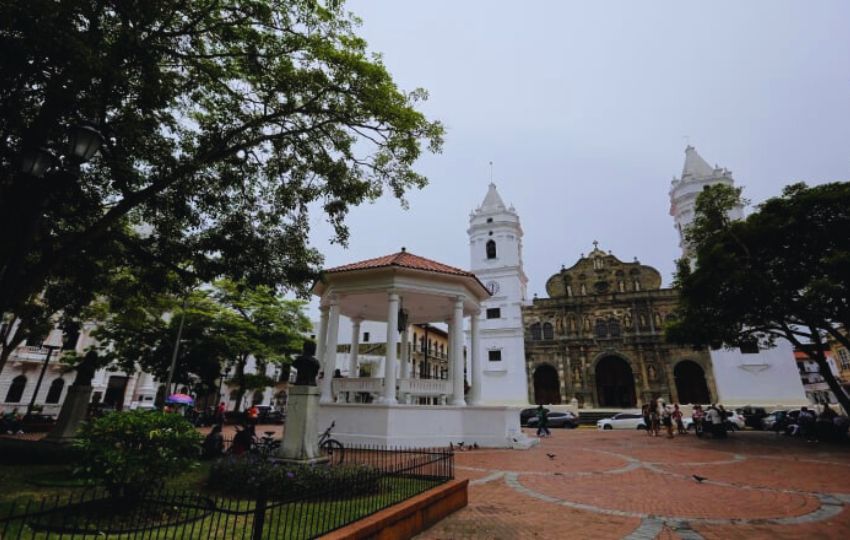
(277, 386), (328, 464)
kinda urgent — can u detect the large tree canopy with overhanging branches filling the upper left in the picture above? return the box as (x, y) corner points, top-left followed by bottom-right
(0, 0), (443, 313)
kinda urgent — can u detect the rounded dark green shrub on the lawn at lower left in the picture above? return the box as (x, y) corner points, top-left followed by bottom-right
(75, 411), (201, 496)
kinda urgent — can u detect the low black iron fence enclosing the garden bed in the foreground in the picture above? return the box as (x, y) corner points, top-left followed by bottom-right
(0, 446), (454, 540)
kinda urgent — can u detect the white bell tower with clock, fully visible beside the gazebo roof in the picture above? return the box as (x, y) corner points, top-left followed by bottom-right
(467, 183), (528, 406)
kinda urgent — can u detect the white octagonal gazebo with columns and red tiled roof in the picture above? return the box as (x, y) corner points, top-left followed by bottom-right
(313, 248), (536, 447)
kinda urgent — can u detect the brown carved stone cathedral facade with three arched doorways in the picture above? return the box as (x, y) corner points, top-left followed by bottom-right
(523, 243), (717, 408)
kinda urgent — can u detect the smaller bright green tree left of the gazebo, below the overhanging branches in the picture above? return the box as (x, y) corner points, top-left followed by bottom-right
(91, 280), (311, 409)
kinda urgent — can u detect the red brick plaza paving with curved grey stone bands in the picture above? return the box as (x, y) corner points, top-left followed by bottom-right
(419, 429), (850, 539)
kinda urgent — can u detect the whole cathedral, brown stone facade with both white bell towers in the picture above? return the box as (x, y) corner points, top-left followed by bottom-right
(467, 146), (806, 409)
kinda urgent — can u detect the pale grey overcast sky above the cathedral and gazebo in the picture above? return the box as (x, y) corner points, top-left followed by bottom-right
(304, 0), (850, 314)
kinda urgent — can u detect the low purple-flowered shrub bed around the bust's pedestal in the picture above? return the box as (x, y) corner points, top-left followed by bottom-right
(207, 456), (381, 500)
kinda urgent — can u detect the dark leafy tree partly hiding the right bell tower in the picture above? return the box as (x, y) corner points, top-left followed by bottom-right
(667, 183), (850, 413)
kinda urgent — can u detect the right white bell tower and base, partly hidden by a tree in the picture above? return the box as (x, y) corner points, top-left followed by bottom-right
(670, 146), (807, 406)
